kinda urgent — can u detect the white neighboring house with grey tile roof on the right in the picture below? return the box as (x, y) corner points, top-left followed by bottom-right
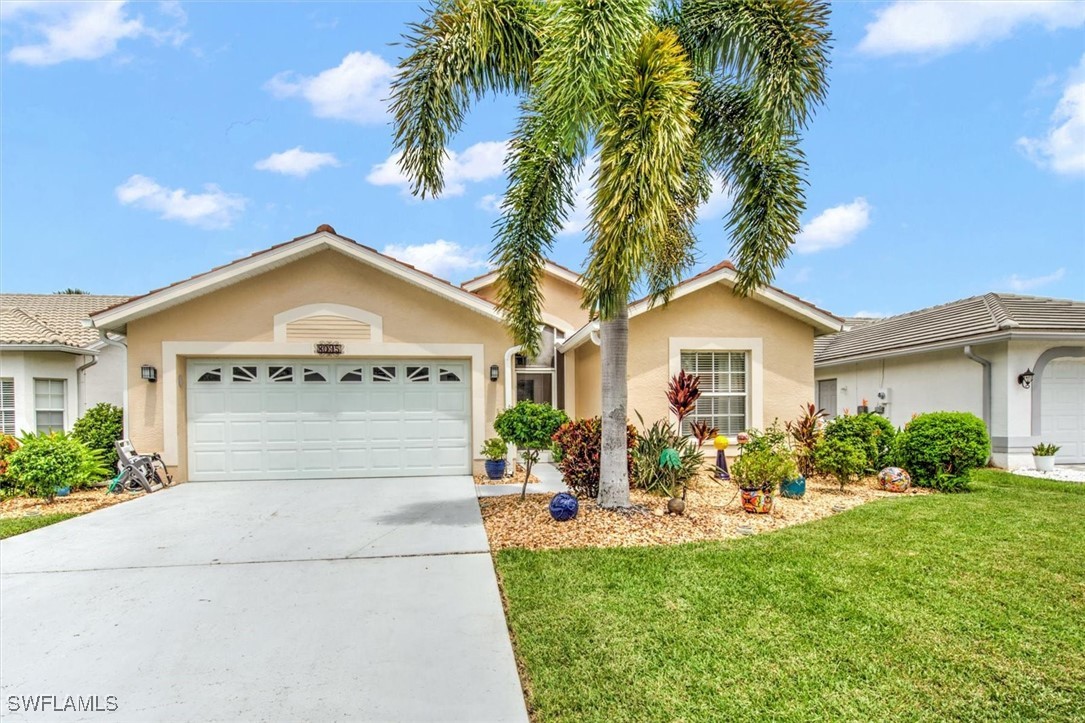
(815, 293), (1085, 468)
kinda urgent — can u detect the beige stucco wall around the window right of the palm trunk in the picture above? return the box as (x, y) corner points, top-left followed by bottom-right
(575, 284), (814, 438)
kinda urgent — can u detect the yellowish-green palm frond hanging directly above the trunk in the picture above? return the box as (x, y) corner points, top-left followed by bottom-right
(584, 28), (697, 319)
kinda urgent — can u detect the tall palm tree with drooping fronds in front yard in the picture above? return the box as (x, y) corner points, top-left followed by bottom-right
(392, 0), (829, 508)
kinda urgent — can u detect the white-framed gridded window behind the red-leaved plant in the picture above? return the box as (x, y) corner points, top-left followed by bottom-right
(681, 350), (749, 434)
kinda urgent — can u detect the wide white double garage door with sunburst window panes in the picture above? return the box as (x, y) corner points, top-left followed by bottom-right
(188, 359), (471, 480)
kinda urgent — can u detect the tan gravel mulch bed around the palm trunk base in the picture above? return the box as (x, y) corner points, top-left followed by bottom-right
(478, 477), (930, 550)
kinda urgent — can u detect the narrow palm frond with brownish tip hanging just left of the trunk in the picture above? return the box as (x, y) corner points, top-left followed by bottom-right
(490, 107), (574, 356)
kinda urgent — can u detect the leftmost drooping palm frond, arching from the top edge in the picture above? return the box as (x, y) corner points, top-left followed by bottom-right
(391, 0), (539, 198)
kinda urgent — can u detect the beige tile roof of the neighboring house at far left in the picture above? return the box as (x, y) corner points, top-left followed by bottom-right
(0, 294), (128, 346)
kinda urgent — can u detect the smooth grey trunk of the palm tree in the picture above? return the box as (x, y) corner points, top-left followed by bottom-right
(599, 305), (629, 509)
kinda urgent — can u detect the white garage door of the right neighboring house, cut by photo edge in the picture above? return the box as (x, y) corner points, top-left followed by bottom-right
(1039, 359), (1085, 464)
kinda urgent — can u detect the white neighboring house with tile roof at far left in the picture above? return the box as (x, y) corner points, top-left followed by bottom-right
(0, 294), (127, 434)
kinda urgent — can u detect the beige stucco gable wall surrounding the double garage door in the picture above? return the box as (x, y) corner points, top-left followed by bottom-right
(127, 251), (511, 479)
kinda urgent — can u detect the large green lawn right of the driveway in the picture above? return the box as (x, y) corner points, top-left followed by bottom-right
(497, 470), (1085, 722)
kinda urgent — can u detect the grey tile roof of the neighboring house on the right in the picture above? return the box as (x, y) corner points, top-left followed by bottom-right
(814, 293), (1085, 364)
